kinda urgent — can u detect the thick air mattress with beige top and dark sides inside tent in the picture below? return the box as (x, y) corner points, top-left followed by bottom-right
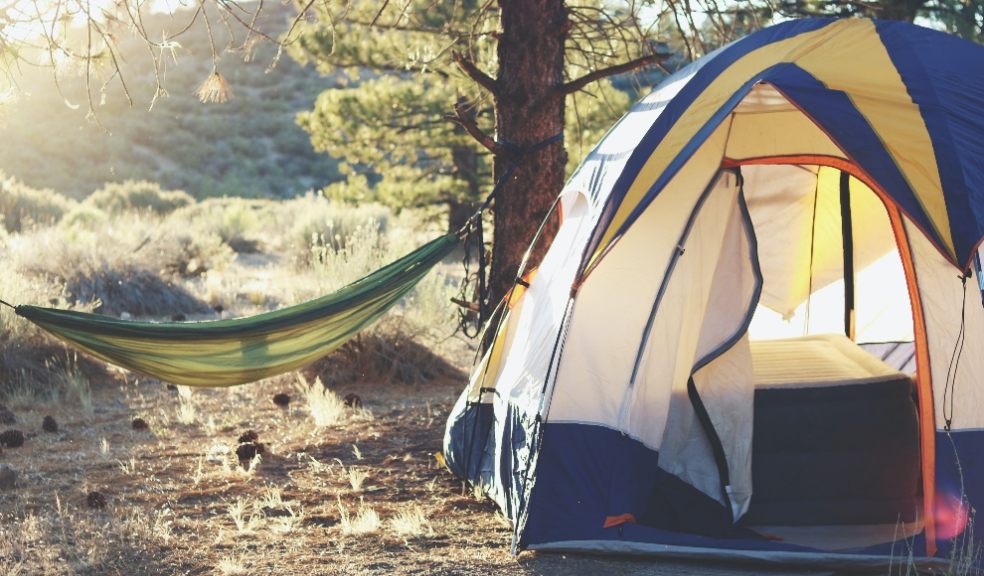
(743, 335), (920, 526)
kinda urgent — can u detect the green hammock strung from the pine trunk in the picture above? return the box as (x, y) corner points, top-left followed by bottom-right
(15, 234), (458, 386)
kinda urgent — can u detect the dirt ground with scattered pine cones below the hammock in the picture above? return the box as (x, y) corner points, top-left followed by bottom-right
(0, 366), (860, 575)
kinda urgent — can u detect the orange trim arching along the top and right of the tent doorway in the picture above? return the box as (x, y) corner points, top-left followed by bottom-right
(721, 154), (950, 556)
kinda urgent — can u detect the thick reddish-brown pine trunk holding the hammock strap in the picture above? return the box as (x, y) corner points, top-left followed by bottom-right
(490, 0), (569, 305)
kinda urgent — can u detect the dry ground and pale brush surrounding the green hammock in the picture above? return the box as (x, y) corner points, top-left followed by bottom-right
(0, 191), (876, 576)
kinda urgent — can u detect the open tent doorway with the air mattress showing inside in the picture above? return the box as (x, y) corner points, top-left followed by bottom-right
(732, 159), (922, 550)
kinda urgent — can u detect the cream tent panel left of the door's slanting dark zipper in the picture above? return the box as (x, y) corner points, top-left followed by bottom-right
(548, 126), (727, 428)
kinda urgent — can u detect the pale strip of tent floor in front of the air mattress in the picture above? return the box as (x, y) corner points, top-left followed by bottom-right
(749, 520), (923, 552)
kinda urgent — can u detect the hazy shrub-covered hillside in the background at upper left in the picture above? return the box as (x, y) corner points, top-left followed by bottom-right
(0, 4), (339, 198)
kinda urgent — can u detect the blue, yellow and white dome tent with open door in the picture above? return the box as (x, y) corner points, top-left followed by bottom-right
(444, 19), (984, 566)
